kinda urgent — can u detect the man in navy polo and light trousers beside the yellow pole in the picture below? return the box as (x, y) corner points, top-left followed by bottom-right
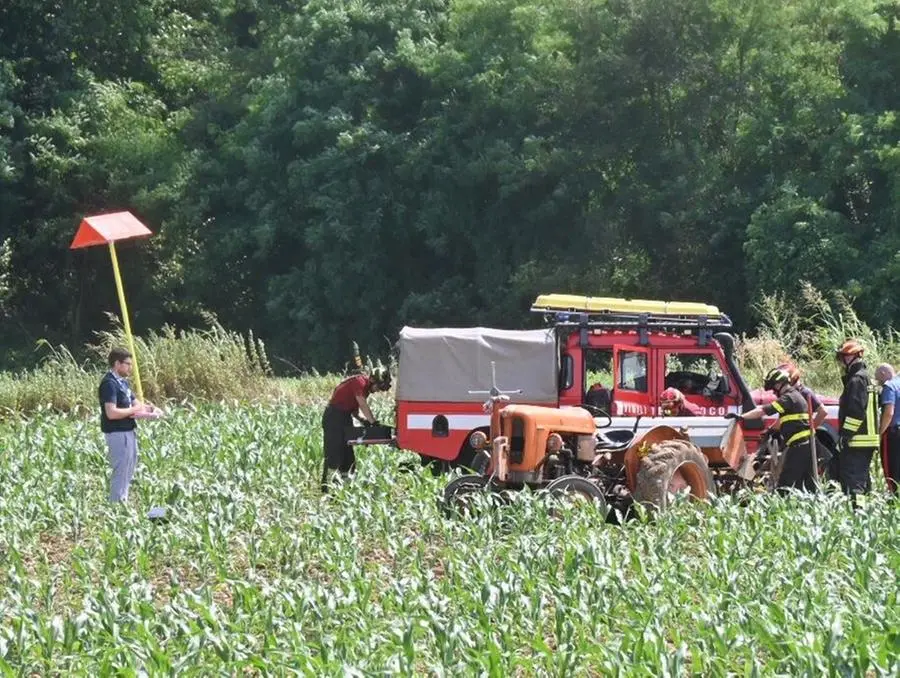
(98, 348), (144, 502)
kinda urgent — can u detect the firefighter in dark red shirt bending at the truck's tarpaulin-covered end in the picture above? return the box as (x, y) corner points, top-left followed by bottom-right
(322, 367), (391, 492)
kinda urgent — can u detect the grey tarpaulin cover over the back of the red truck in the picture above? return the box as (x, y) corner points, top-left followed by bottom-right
(397, 327), (559, 403)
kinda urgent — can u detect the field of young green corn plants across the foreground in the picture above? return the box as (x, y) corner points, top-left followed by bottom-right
(0, 402), (900, 676)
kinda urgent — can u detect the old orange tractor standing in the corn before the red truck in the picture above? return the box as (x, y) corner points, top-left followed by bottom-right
(443, 365), (755, 519)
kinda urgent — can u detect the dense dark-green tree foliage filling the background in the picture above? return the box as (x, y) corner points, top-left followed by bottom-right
(0, 0), (900, 368)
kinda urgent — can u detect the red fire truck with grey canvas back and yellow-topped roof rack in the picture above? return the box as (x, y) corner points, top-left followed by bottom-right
(373, 294), (837, 466)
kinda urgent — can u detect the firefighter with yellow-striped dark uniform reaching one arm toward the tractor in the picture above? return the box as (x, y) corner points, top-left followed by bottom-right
(725, 367), (816, 492)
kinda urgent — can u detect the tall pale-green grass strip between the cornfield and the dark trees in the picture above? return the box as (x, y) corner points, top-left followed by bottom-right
(0, 285), (900, 416)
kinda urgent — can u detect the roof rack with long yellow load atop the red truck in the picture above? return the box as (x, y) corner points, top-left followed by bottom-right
(531, 294), (732, 343)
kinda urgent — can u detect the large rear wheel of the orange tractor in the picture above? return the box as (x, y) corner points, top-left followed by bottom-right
(634, 440), (716, 510)
